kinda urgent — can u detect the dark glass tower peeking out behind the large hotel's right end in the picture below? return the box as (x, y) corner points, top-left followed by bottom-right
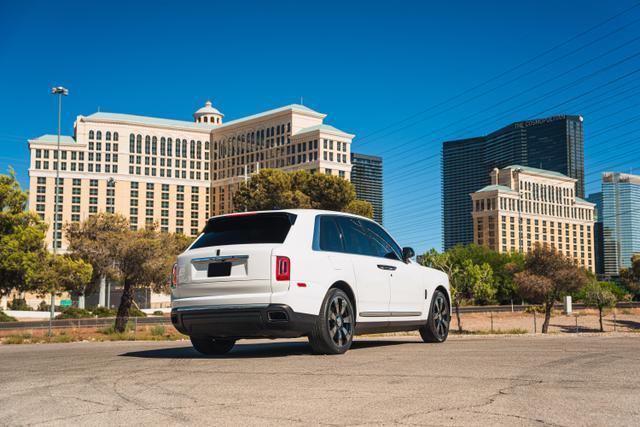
(351, 152), (383, 224)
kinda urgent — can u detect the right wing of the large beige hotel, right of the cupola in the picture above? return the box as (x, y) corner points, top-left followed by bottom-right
(211, 105), (354, 215)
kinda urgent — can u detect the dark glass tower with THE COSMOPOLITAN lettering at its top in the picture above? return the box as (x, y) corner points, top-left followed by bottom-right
(442, 116), (584, 250)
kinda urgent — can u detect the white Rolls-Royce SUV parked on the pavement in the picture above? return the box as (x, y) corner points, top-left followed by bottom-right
(171, 209), (451, 354)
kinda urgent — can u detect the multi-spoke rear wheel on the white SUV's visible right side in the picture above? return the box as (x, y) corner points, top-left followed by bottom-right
(309, 288), (356, 354)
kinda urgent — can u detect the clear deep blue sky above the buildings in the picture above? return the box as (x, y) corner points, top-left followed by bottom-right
(0, 0), (640, 252)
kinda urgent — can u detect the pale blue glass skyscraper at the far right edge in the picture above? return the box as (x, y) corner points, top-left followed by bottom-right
(602, 172), (640, 276)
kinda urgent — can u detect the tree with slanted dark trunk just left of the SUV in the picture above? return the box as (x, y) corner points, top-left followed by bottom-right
(68, 213), (191, 332)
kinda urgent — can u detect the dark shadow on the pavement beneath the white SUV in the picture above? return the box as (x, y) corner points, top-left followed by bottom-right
(120, 339), (415, 359)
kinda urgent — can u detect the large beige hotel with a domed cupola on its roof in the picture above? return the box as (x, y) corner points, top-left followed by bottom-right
(29, 102), (354, 250)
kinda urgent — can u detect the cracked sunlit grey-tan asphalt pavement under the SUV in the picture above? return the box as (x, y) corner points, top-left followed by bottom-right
(0, 334), (640, 426)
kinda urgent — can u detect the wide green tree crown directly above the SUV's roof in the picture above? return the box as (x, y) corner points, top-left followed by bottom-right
(233, 169), (373, 217)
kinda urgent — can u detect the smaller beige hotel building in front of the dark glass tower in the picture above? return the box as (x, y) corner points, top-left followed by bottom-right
(471, 165), (595, 271)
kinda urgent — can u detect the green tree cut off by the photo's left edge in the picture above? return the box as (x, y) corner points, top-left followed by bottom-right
(0, 169), (47, 296)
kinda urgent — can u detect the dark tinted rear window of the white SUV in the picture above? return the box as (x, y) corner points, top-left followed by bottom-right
(191, 212), (296, 249)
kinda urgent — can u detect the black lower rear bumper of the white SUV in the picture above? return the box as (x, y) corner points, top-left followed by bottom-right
(171, 304), (317, 338)
